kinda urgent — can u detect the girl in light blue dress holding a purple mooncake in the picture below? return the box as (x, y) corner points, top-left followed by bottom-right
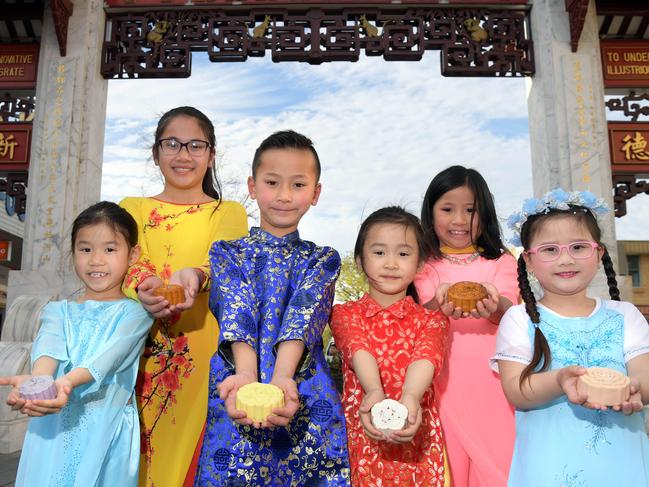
(0, 202), (152, 487)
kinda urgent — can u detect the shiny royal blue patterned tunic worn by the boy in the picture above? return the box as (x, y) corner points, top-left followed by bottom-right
(195, 228), (349, 487)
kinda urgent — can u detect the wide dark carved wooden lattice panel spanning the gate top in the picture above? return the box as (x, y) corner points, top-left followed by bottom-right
(101, 6), (534, 78)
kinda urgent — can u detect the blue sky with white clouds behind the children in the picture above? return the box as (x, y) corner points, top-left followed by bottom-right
(102, 52), (649, 252)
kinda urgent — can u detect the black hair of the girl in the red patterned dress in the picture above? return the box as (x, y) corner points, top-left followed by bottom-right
(354, 206), (430, 303)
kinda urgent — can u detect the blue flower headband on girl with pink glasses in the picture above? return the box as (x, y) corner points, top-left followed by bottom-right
(507, 188), (609, 246)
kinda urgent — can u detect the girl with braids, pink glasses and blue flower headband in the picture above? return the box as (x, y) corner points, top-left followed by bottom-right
(492, 190), (649, 487)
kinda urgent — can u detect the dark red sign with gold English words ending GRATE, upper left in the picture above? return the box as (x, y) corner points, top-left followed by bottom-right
(0, 44), (39, 89)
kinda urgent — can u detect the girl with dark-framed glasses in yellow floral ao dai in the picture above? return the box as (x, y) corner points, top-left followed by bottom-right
(121, 107), (247, 487)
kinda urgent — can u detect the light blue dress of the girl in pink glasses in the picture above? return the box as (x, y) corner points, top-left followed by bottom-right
(509, 300), (649, 487)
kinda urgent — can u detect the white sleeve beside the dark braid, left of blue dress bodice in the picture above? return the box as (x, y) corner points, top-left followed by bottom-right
(489, 304), (534, 372)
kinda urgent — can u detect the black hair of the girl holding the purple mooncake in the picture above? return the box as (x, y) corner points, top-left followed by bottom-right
(71, 201), (138, 252)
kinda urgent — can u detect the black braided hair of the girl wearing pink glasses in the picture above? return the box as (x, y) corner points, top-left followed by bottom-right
(518, 205), (620, 385)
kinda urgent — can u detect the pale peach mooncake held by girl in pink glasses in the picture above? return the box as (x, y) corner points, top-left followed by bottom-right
(577, 367), (631, 406)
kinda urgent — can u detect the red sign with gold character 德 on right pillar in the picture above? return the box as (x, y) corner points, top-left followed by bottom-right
(608, 122), (649, 174)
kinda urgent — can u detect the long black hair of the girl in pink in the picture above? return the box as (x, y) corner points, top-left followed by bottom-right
(421, 166), (508, 259)
